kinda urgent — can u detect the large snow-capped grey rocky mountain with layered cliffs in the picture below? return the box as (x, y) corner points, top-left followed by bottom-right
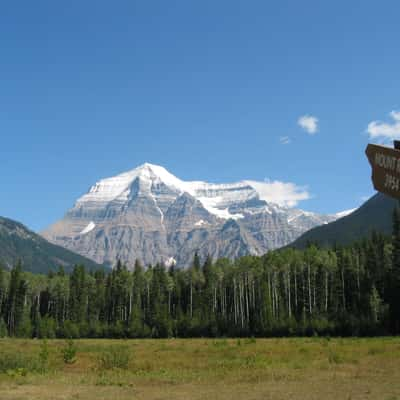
(41, 163), (342, 267)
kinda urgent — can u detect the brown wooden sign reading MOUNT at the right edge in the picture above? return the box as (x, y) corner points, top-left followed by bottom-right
(365, 144), (400, 199)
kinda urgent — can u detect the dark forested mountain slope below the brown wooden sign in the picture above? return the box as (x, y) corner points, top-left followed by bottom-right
(290, 193), (398, 248)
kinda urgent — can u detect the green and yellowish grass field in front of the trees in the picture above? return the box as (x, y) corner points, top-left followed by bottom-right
(0, 338), (400, 400)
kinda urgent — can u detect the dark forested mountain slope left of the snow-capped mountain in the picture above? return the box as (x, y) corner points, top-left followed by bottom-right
(0, 217), (103, 273)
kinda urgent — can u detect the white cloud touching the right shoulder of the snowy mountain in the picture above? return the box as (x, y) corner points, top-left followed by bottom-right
(246, 181), (311, 207)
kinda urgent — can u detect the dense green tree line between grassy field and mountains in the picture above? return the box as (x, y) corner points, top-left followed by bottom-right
(0, 210), (400, 338)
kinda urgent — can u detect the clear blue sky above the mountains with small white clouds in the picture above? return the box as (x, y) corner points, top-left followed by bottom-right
(0, 0), (400, 231)
